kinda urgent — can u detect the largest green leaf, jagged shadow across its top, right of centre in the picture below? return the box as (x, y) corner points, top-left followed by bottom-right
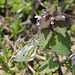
(49, 34), (70, 56)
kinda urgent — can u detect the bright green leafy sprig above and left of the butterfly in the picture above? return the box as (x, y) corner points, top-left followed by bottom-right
(9, 19), (24, 38)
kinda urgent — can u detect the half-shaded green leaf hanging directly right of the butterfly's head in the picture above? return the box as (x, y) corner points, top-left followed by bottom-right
(38, 29), (53, 49)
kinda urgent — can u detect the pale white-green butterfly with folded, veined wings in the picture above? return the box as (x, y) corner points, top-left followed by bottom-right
(15, 38), (38, 62)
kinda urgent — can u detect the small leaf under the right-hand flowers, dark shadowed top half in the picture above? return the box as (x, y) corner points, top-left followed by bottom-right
(53, 21), (66, 37)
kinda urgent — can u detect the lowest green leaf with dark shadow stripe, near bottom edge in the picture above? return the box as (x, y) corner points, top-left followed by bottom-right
(38, 57), (59, 73)
